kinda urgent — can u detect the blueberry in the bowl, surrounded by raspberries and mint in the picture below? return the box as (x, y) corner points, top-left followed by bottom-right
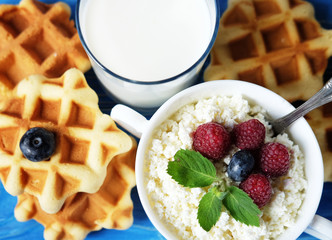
(227, 150), (255, 182)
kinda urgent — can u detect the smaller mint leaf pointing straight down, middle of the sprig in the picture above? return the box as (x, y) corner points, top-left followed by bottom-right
(197, 187), (227, 232)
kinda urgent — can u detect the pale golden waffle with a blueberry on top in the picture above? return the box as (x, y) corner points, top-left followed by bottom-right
(0, 69), (132, 213)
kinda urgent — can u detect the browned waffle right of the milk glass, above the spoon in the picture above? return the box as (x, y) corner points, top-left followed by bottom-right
(204, 0), (332, 101)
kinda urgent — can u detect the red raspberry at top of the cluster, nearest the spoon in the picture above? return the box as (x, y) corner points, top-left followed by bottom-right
(233, 119), (265, 150)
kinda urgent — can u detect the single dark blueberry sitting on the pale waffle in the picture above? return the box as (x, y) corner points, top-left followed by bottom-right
(20, 127), (55, 162)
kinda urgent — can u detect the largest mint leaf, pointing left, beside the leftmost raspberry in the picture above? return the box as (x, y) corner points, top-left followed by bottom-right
(167, 149), (216, 188)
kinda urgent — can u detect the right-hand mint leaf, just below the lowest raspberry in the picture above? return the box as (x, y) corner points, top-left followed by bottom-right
(223, 186), (261, 227)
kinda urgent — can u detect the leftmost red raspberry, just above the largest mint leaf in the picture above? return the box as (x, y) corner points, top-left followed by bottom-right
(193, 122), (231, 160)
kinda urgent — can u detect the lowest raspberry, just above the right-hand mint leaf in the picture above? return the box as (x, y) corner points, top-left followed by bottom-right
(240, 173), (272, 208)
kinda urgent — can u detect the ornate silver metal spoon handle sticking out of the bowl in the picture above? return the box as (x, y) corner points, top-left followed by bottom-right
(271, 78), (332, 135)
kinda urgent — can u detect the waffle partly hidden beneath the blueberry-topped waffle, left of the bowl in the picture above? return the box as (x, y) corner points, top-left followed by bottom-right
(15, 137), (137, 240)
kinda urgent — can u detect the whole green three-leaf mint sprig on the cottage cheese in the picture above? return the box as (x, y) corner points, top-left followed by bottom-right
(167, 149), (261, 232)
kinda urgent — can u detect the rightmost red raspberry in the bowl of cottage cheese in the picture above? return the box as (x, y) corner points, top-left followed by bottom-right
(259, 142), (289, 177)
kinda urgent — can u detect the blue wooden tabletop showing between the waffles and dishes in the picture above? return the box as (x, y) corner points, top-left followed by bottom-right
(0, 0), (332, 240)
